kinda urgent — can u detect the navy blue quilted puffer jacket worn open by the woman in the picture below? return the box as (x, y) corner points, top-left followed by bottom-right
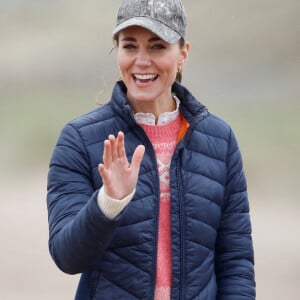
(47, 82), (255, 300)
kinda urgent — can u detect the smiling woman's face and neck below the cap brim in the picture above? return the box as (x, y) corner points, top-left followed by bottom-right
(117, 26), (189, 113)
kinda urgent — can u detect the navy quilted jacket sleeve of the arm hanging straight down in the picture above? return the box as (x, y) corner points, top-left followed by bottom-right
(215, 127), (255, 300)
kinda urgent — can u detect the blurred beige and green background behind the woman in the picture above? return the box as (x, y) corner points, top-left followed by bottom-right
(0, 0), (300, 300)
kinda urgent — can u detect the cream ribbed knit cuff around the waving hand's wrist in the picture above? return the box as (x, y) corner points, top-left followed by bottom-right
(97, 186), (135, 219)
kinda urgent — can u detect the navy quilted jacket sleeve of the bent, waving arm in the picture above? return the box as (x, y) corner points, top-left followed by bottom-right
(47, 125), (120, 274)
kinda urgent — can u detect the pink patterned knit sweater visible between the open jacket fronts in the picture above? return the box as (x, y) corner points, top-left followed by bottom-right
(140, 113), (181, 300)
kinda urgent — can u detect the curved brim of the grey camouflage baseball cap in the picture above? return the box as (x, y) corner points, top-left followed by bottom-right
(113, 17), (181, 44)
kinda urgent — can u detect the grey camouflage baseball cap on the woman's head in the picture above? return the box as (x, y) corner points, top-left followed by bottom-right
(113, 0), (186, 44)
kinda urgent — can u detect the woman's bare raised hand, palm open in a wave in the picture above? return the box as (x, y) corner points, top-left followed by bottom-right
(98, 132), (145, 200)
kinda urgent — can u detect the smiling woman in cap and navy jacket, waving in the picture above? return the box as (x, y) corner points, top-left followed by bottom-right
(47, 0), (255, 300)
